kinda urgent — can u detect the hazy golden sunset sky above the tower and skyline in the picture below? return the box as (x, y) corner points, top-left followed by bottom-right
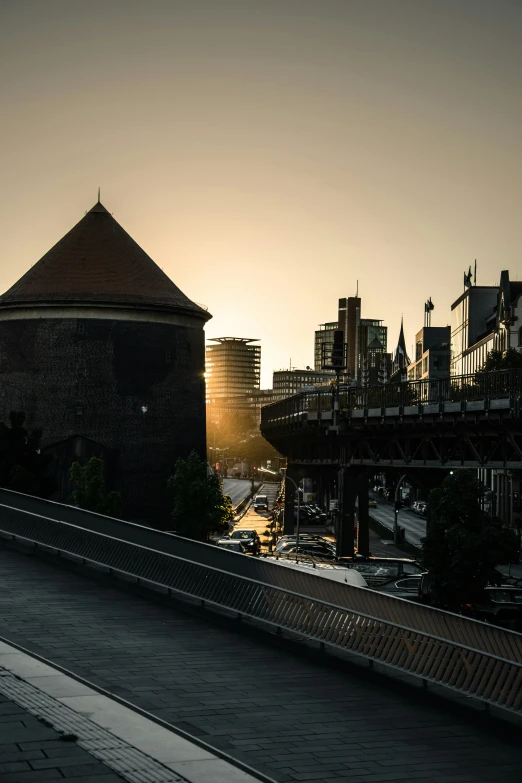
(0, 0), (522, 388)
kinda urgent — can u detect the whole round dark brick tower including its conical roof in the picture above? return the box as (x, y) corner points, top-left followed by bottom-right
(0, 201), (211, 523)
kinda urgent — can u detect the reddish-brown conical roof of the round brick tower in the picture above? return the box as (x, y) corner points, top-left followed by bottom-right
(0, 201), (210, 320)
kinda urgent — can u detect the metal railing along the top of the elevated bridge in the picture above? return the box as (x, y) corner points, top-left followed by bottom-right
(261, 370), (522, 430)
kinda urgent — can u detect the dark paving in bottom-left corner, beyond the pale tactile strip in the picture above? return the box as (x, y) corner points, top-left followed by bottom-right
(0, 695), (124, 783)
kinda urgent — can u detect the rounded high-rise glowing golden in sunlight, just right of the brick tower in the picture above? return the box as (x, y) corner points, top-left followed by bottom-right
(205, 337), (261, 404)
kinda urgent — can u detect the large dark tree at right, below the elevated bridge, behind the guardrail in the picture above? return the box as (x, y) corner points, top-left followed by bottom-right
(422, 470), (518, 612)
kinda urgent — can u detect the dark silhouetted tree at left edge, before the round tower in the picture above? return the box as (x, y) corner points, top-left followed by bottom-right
(0, 411), (56, 497)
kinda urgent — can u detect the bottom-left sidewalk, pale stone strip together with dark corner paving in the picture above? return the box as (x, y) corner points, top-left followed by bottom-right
(0, 641), (267, 783)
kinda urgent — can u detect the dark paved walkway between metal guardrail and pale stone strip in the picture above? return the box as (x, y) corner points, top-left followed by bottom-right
(0, 548), (522, 783)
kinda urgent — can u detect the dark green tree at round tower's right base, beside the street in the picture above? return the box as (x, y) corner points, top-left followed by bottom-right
(168, 451), (234, 541)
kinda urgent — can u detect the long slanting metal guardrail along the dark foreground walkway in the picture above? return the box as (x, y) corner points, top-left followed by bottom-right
(0, 500), (522, 714)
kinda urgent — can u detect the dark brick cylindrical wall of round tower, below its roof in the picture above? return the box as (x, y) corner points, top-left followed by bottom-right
(0, 318), (205, 523)
